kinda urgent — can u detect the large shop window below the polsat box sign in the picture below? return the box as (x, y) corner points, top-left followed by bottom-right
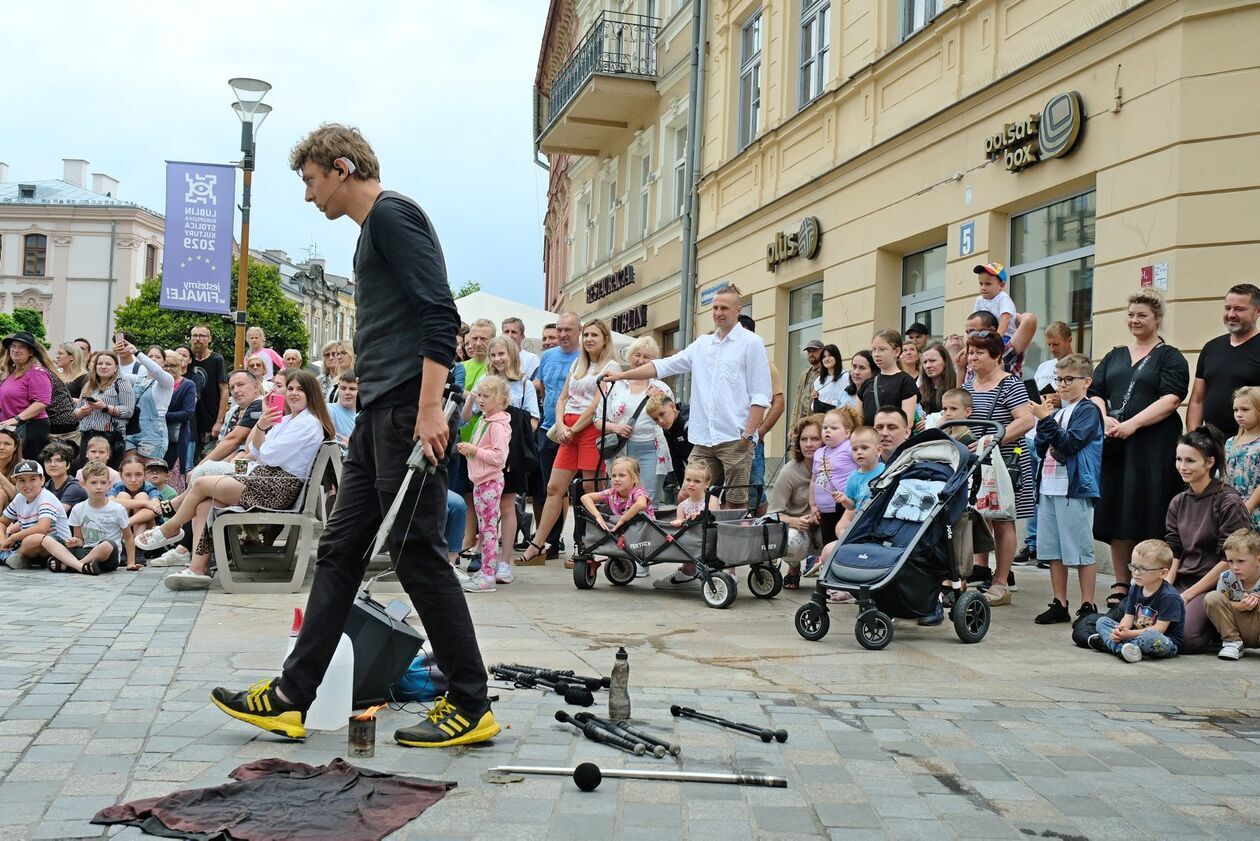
(1007, 190), (1097, 371)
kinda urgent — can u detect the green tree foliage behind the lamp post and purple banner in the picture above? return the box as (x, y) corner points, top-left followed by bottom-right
(113, 260), (310, 362)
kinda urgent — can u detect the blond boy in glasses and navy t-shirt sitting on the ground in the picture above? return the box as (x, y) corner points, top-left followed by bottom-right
(1087, 540), (1186, 663)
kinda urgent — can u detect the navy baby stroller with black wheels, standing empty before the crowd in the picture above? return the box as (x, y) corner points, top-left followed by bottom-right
(796, 419), (1005, 651)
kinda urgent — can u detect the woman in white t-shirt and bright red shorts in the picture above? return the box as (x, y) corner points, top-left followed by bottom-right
(517, 319), (621, 567)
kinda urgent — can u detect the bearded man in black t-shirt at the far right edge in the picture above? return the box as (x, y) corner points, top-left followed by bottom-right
(1186, 284), (1260, 438)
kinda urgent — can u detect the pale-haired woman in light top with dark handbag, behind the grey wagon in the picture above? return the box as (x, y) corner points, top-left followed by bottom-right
(595, 335), (674, 504)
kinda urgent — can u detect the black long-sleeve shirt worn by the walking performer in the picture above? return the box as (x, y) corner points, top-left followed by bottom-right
(354, 190), (460, 409)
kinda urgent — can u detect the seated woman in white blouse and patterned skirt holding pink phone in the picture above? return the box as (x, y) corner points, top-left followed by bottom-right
(136, 371), (334, 590)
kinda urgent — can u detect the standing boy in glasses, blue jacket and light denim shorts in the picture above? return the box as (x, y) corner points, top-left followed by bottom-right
(1028, 353), (1103, 625)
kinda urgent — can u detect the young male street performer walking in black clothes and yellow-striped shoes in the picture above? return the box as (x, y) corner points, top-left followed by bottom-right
(212, 124), (499, 748)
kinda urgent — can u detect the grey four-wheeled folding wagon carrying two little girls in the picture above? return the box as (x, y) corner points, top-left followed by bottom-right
(570, 477), (788, 608)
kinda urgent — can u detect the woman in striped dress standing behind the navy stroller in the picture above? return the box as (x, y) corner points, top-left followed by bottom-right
(963, 330), (1037, 605)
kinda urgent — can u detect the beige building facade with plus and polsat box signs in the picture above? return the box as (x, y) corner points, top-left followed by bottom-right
(690, 0), (1260, 455)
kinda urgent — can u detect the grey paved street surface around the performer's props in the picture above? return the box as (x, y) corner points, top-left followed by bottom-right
(0, 562), (1260, 841)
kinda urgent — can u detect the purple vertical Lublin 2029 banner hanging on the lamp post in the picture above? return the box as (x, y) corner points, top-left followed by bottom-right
(159, 160), (236, 314)
